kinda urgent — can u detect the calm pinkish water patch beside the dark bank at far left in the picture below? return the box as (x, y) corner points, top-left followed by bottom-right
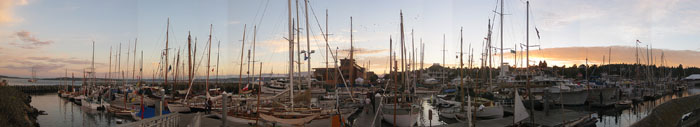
(31, 93), (127, 127)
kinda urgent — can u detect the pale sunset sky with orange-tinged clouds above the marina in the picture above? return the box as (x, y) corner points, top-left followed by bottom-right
(0, 0), (700, 78)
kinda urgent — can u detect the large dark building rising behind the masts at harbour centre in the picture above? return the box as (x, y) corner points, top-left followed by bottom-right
(313, 59), (376, 84)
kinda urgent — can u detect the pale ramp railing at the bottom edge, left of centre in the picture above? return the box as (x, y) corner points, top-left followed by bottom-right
(120, 113), (180, 127)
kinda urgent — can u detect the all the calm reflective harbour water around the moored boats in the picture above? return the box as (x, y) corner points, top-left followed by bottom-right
(31, 88), (700, 127)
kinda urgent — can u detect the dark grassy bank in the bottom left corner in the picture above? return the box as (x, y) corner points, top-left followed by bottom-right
(0, 86), (39, 127)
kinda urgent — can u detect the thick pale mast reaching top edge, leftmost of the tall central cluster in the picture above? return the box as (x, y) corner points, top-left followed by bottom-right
(286, 0), (294, 110)
